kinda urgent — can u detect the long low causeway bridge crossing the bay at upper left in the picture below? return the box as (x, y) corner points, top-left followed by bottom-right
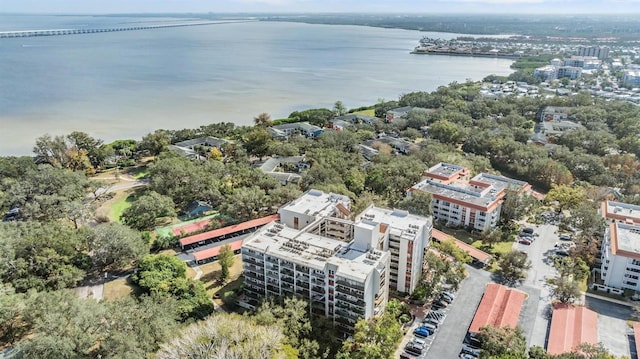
(0, 20), (255, 39)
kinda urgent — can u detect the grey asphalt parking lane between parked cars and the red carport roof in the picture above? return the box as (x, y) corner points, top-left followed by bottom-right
(426, 266), (491, 359)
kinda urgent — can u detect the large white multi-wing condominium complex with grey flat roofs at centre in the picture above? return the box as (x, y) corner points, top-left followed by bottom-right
(242, 190), (432, 333)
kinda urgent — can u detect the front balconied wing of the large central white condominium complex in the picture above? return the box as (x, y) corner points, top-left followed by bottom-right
(242, 222), (390, 332)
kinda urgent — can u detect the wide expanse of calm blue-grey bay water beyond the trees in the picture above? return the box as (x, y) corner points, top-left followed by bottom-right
(0, 15), (512, 155)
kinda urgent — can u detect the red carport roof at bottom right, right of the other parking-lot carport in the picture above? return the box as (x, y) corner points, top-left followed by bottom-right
(547, 304), (598, 355)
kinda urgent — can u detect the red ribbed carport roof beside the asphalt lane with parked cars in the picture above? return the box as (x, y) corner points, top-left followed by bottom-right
(469, 283), (526, 333)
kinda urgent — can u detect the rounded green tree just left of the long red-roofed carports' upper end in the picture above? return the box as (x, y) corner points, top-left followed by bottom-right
(122, 191), (176, 231)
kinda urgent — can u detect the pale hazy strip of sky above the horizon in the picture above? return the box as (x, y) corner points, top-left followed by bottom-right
(0, 0), (640, 15)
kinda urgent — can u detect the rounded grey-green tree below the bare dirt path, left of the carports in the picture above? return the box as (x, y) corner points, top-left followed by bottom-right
(89, 223), (149, 270)
